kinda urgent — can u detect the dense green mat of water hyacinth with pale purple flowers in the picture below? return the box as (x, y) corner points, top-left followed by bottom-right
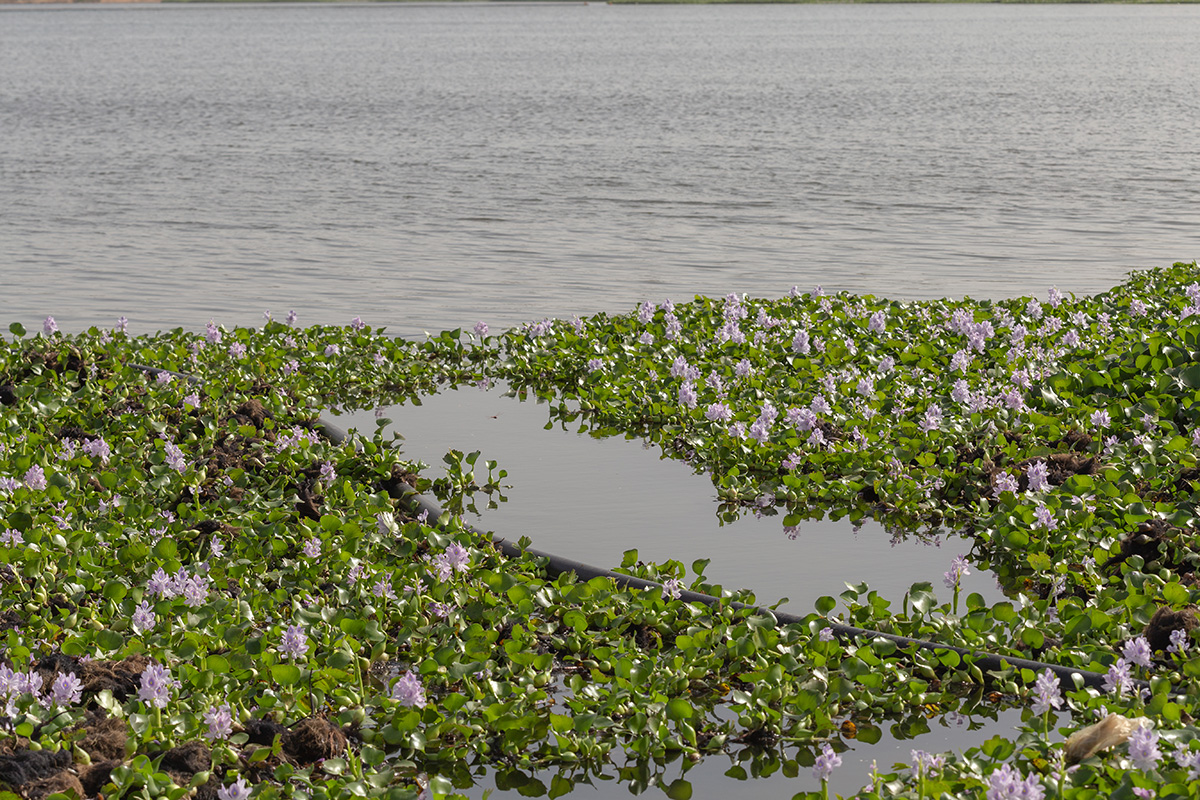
(7, 264), (1200, 798)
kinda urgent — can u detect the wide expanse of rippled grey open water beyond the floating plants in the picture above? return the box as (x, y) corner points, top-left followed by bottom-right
(0, 4), (1200, 335)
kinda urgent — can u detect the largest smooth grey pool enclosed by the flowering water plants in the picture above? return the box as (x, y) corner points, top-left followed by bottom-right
(334, 387), (1002, 614)
